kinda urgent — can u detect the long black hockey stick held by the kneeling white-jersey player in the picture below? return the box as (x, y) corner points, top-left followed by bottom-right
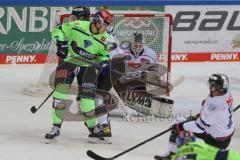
(87, 104), (240, 160)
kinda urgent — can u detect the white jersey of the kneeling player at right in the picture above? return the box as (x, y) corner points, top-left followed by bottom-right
(183, 90), (235, 138)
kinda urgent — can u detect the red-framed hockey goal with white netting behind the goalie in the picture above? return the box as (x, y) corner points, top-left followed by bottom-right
(24, 11), (172, 96)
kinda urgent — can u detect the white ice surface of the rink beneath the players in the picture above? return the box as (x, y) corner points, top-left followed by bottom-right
(0, 62), (240, 160)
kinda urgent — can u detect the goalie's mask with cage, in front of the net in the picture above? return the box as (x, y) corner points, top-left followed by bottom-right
(131, 33), (144, 57)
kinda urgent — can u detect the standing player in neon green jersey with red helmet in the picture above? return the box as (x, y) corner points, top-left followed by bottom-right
(45, 6), (112, 142)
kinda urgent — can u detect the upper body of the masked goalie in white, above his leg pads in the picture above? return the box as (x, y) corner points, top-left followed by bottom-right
(110, 33), (172, 96)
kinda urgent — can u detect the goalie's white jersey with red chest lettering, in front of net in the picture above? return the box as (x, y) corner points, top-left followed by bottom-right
(110, 46), (157, 71)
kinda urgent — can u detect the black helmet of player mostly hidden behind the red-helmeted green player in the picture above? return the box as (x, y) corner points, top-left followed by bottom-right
(72, 6), (90, 21)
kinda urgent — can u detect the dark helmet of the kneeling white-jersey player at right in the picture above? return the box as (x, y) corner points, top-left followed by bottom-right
(208, 73), (229, 92)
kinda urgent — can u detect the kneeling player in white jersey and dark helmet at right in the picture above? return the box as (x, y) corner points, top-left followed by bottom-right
(155, 74), (234, 160)
